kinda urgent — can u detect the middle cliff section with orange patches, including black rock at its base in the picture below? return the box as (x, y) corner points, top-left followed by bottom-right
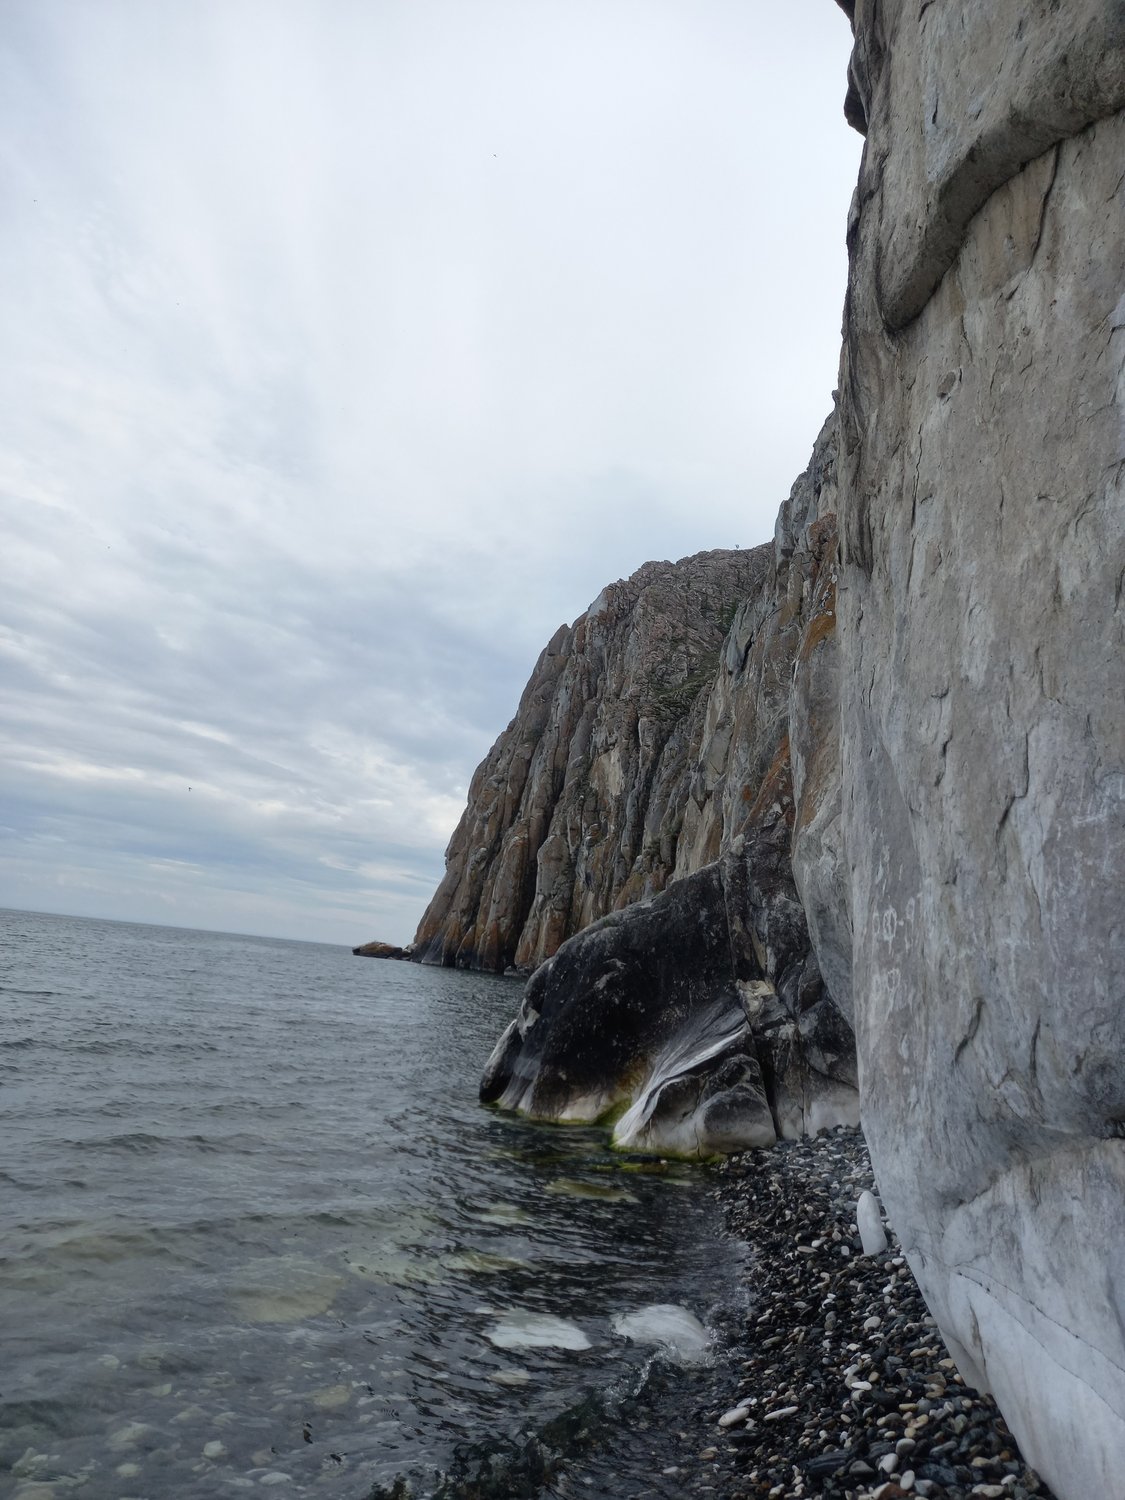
(470, 420), (858, 1155)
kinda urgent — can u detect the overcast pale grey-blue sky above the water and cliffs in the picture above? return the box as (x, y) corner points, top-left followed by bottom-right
(0, 0), (861, 944)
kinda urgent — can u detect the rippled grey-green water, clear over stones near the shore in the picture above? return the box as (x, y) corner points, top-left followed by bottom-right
(0, 912), (753, 1500)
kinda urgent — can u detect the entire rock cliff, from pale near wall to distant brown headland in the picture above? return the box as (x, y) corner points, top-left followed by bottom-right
(402, 0), (1125, 1500)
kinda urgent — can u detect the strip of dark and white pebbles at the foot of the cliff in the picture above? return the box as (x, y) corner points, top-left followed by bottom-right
(693, 1130), (1052, 1500)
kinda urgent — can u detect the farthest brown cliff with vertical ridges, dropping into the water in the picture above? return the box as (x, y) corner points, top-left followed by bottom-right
(414, 546), (773, 969)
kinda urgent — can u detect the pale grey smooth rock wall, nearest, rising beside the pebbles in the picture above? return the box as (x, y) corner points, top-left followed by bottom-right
(840, 0), (1125, 1500)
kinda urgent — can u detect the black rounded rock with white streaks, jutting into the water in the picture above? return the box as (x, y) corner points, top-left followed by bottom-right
(480, 822), (858, 1157)
